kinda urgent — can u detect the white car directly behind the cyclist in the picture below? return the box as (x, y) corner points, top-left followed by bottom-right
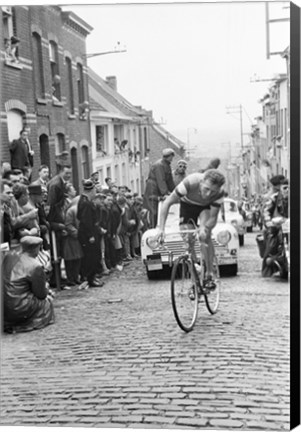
(141, 203), (239, 279)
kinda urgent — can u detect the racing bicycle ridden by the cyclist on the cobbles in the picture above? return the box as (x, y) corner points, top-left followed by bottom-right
(171, 229), (221, 333)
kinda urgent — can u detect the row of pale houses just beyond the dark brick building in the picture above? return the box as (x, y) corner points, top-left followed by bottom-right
(89, 68), (184, 195)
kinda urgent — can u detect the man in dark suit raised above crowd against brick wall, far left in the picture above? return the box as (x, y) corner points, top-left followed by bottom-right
(9, 128), (34, 178)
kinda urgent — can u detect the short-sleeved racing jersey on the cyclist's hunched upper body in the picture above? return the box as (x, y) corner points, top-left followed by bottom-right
(175, 173), (224, 208)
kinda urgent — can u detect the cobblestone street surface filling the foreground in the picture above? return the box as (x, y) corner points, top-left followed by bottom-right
(0, 233), (289, 431)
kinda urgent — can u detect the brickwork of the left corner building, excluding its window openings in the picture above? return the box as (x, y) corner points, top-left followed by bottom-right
(1, 6), (92, 188)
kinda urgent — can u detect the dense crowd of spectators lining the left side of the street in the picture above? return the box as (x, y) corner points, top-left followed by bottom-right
(0, 163), (149, 331)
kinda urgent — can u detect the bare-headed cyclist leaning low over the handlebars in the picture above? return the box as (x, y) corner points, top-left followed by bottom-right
(156, 169), (225, 289)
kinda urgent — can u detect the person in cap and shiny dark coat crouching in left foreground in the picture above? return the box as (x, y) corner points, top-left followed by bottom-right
(2, 236), (54, 332)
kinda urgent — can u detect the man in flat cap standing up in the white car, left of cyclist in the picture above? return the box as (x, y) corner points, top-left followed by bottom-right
(143, 148), (175, 228)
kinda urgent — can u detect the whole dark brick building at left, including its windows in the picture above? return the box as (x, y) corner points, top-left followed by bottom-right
(0, 6), (92, 190)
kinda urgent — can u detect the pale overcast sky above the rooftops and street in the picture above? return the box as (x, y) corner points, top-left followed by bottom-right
(63, 2), (289, 156)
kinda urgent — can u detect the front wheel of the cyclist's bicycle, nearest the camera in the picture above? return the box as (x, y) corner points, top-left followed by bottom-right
(171, 256), (198, 332)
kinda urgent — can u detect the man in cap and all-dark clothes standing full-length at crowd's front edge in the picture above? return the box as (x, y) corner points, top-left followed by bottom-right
(77, 179), (104, 289)
